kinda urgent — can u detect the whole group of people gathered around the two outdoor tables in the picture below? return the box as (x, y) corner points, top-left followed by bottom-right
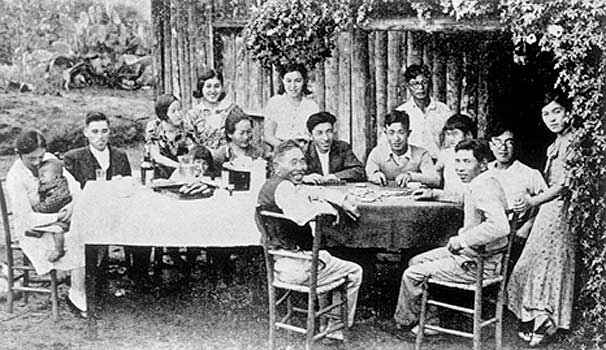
(7, 60), (575, 345)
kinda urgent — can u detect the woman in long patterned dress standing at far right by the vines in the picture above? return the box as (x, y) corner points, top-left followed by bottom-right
(507, 92), (577, 346)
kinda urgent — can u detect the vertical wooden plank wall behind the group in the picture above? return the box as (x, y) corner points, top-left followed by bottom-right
(152, 0), (509, 160)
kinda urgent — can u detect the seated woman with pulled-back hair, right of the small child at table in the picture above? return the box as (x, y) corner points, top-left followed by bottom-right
(213, 107), (264, 169)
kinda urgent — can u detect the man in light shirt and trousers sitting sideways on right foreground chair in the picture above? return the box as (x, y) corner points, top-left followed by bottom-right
(394, 139), (509, 335)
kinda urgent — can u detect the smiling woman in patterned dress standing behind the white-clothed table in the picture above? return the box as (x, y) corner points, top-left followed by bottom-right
(185, 69), (234, 150)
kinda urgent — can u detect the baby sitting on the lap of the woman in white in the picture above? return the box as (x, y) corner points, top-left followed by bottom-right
(32, 159), (72, 262)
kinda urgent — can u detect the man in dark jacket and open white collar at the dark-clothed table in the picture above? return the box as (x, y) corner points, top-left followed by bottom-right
(303, 112), (366, 185)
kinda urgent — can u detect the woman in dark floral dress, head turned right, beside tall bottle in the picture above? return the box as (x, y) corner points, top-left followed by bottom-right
(145, 95), (193, 179)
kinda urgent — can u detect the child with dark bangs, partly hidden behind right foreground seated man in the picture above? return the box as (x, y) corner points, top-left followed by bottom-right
(436, 114), (477, 196)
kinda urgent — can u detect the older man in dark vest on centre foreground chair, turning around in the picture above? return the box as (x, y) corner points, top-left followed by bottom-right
(257, 140), (362, 339)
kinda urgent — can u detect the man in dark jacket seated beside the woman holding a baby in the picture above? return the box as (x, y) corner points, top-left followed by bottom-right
(63, 112), (131, 188)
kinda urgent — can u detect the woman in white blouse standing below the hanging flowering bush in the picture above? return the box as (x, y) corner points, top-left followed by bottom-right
(264, 64), (320, 148)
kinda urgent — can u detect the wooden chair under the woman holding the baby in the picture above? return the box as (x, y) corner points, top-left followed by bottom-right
(0, 179), (59, 320)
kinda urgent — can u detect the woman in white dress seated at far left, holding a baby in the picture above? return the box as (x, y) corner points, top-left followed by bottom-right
(6, 131), (86, 316)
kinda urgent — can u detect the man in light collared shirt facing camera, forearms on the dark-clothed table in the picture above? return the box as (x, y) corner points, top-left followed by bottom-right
(366, 111), (441, 187)
